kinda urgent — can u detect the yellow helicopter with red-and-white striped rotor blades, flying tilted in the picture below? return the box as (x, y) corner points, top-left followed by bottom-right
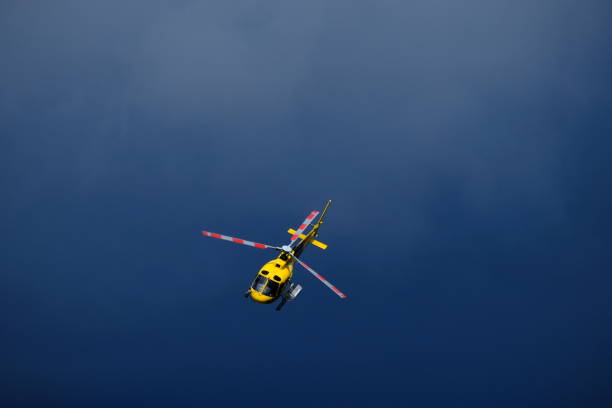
(202, 200), (346, 310)
